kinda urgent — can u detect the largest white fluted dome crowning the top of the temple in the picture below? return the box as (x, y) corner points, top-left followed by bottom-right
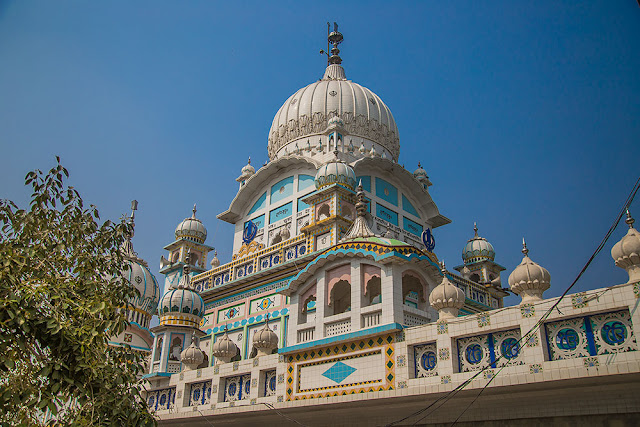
(269, 64), (400, 161)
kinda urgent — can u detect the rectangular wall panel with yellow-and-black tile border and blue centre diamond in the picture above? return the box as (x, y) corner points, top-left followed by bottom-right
(285, 333), (396, 401)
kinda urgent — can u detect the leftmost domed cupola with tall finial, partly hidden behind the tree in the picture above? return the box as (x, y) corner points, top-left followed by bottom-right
(122, 200), (160, 323)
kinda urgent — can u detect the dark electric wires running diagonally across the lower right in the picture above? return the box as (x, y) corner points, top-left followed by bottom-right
(386, 177), (640, 427)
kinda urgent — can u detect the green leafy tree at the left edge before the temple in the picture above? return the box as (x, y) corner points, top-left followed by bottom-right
(0, 158), (156, 426)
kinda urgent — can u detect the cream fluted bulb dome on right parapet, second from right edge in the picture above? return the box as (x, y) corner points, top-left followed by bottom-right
(509, 239), (551, 303)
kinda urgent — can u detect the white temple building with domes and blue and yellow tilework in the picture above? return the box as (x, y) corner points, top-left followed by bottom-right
(110, 26), (640, 426)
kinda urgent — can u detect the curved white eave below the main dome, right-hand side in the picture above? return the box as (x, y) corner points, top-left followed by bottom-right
(353, 157), (451, 228)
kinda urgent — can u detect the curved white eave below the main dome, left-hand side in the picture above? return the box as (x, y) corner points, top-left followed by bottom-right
(218, 155), (320, 224)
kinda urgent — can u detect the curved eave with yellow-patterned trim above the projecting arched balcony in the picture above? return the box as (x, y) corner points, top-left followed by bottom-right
(280, 238), (440, 295)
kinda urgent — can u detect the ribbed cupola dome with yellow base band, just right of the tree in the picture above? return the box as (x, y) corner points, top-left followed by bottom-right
(158, 262), (204, 328)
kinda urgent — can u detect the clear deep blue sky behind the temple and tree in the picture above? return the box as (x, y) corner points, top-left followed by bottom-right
(0, 0), (640, 303)
